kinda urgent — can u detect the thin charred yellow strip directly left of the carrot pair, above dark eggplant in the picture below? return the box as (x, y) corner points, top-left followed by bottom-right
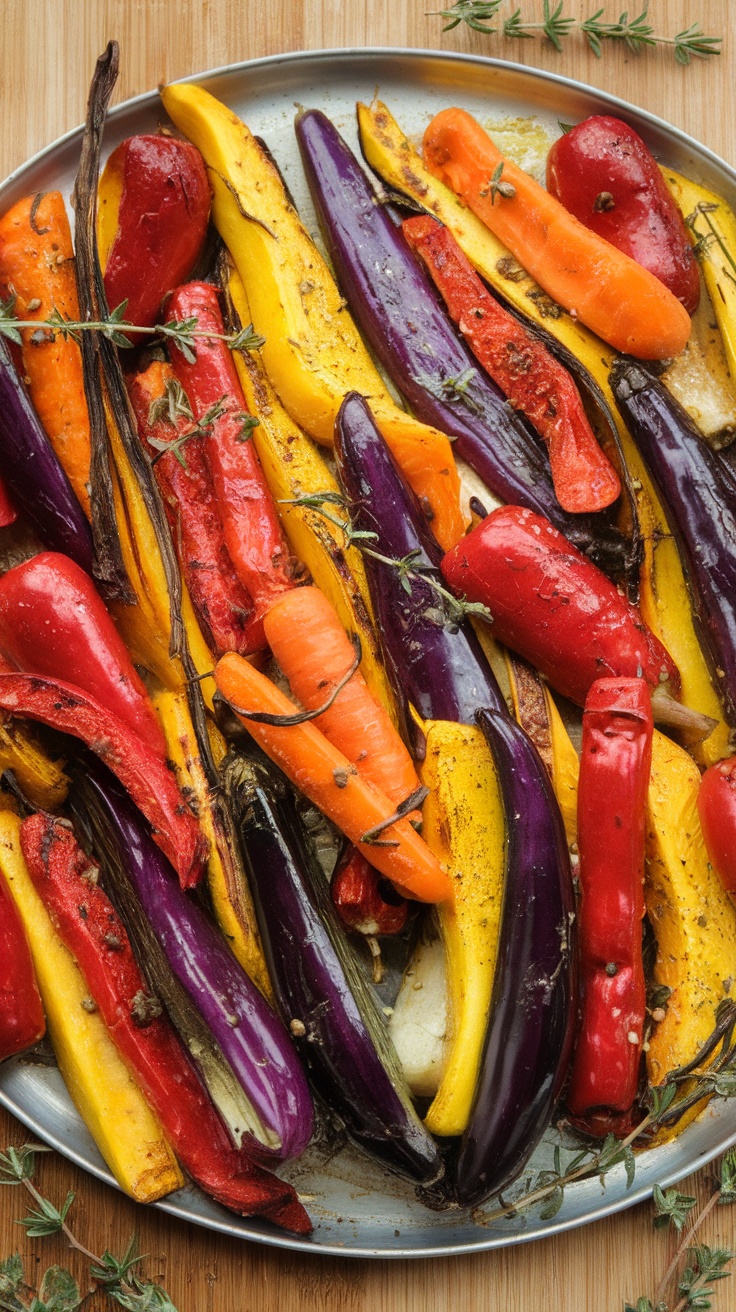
(152, 690), (273, 1002)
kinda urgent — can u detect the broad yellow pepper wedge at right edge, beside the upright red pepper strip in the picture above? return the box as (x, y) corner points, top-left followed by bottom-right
(644, 731), (736, 1112)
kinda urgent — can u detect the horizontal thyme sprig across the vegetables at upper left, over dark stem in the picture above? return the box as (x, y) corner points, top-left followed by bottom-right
(0, 295), (265, 363)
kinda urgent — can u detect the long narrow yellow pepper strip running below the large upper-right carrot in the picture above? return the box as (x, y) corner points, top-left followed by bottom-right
(358, 100), (728, 765)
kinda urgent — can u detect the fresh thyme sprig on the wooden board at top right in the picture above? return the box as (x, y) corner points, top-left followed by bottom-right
(428, 0), (723, 64)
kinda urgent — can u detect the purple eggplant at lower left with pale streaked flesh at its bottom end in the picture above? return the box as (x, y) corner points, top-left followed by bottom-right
(68, 760), (314, 1157)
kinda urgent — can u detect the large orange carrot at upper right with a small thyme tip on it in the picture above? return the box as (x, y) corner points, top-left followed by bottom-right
(424, 109), (690, 359)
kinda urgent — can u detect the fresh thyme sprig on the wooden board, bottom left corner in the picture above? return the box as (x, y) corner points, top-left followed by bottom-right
(0, 1144), (176, 1312)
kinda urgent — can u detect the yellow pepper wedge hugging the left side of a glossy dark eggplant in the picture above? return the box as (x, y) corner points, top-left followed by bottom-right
(420, 720), (505, 1135)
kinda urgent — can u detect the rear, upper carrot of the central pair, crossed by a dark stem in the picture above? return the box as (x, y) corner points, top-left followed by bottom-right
(264, 588), (420, 804)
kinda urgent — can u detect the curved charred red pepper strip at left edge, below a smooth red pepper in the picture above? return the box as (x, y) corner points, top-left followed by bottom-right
(0, 673), (207, 888)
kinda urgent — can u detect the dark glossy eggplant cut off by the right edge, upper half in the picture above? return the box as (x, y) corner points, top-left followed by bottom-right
(610, 361), (736, 726)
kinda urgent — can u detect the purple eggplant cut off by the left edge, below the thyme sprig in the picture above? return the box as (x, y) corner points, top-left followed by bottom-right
(0, 337), (93, 575)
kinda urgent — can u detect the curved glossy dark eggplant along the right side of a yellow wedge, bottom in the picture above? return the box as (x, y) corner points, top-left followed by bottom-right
(455, 710), (575, 1207)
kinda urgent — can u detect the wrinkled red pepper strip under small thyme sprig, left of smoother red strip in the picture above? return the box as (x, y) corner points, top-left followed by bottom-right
(127, 361), (258, 656)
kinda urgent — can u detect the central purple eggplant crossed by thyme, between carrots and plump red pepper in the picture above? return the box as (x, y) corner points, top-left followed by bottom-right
(335, 392), (506, 749)
